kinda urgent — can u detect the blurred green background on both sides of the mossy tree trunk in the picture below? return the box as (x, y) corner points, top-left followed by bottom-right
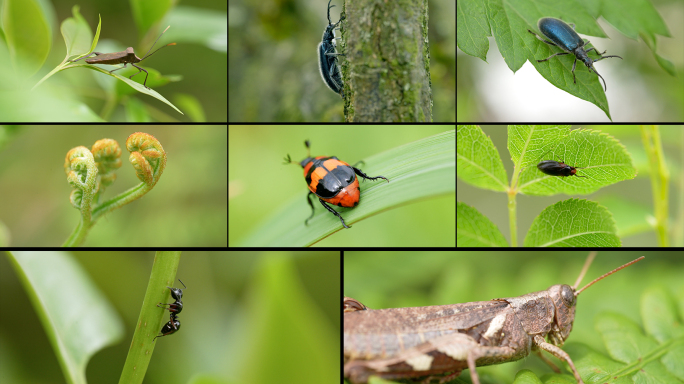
(228, 0), (456, 122)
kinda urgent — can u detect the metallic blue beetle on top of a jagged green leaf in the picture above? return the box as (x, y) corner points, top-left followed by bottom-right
(527, 17), (622, 91)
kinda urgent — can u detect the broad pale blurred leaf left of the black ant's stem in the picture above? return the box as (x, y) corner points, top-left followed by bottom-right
(7, 251), (123, 383)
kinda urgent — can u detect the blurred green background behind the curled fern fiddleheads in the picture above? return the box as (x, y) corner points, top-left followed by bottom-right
(0, 125), (227, 247)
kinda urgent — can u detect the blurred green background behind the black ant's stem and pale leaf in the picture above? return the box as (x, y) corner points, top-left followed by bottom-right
(0, 251), (340, 384)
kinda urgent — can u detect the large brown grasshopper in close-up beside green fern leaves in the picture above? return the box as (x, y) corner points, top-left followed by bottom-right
(343, 254), (644, 384)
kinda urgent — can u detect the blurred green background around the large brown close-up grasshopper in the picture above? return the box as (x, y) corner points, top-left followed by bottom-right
(342, 250), (684, 384)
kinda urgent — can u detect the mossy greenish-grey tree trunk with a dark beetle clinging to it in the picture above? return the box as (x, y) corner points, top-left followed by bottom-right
(338, 0), (432, 122)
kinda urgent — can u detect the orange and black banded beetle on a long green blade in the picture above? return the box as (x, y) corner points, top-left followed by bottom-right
(285, 140), (389, 228)
